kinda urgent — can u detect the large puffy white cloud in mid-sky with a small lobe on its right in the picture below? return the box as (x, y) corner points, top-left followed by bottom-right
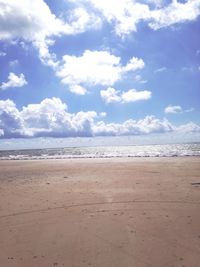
(56, 50), (145, 91)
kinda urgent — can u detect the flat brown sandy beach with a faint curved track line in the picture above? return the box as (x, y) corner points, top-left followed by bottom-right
(0, 157), (200, 267)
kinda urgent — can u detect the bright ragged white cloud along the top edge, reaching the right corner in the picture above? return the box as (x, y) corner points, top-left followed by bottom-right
(70, 0), (200, 37)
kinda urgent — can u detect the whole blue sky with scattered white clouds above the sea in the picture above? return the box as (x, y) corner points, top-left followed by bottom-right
(0, 0), (200, 145)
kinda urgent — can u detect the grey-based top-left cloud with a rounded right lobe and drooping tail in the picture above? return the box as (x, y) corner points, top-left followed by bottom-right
(0, 0), (100, 67)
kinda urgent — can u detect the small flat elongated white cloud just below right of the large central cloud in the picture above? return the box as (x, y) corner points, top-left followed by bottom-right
(100, 87), (151, 104)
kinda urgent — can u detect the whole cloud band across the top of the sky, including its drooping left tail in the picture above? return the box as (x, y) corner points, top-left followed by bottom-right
(0, 0), (200, 68)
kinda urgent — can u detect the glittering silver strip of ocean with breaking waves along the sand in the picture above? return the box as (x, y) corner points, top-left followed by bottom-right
(0, 143), (200, 160)
